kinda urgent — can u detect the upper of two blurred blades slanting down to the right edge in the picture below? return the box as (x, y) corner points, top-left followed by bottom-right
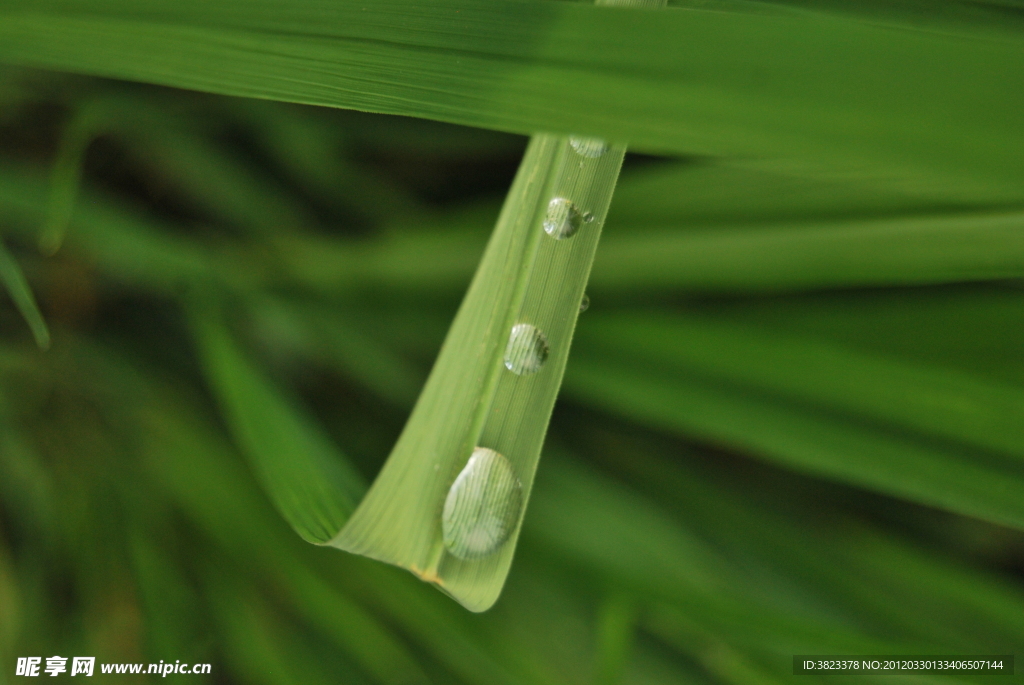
(588, 314), (1024, 456)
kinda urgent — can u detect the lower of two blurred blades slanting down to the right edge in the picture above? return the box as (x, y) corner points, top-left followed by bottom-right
(566, 321), (1024, 527)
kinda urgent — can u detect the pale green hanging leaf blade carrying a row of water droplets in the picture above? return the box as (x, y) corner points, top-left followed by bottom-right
(333, 135), (625, 611)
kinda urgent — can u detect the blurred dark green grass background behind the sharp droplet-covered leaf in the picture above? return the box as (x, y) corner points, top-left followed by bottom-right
(0, 14), (1024, 685)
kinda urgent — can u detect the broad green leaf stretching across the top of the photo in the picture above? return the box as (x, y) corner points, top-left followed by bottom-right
(0, 0), (1024, 200)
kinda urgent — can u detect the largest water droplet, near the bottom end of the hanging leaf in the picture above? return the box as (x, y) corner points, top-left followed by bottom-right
(441, 447), (522, 559)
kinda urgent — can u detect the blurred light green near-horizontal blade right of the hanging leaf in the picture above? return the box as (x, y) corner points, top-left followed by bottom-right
(594, 212), (1024, 295)
